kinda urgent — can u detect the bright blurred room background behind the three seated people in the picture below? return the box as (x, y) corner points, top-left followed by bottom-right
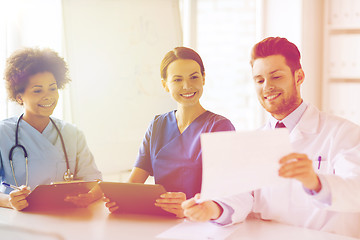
(0, 0), (360, 181)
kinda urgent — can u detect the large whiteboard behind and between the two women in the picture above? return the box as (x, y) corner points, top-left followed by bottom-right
(63, 0), (182, 174)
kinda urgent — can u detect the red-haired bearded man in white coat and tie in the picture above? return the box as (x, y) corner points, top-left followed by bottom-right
(182, 37), (360, 238)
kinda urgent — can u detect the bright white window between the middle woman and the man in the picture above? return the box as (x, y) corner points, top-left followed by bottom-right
(182, 0), (263, 130)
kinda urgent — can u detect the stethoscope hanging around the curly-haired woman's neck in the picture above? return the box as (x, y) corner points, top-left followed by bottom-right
(9, 114), (74, 186)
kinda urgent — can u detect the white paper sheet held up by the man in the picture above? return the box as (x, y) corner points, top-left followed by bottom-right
(201, 129), (292, 199)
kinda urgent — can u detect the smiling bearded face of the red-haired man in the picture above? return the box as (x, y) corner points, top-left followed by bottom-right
(252, 55), (304, 120)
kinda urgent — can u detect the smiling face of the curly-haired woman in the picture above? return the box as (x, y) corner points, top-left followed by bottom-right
(16, 72), (59, 118)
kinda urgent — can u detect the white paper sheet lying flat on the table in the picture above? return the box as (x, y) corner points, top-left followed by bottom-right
(156, 220), (239, 240)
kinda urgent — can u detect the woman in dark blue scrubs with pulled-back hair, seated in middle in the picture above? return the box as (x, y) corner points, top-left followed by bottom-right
(106, 47), (235, 217)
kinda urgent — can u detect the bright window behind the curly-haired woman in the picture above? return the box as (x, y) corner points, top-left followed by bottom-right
(0, 0), (63, 119)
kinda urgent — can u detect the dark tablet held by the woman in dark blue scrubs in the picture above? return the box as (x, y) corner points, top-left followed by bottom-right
(99, 182), (174, 216)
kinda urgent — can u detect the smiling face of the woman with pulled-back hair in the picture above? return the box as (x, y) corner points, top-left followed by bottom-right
(162, 59), (205, 106)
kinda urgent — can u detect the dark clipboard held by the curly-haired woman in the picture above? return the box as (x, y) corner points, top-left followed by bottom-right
(24, 181), (98, 211)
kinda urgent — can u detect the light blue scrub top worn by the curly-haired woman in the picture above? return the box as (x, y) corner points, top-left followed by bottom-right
(0, 117), (102, 193)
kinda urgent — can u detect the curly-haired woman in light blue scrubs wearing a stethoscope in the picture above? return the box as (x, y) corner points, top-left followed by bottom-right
(0, 48), (102, 210)
